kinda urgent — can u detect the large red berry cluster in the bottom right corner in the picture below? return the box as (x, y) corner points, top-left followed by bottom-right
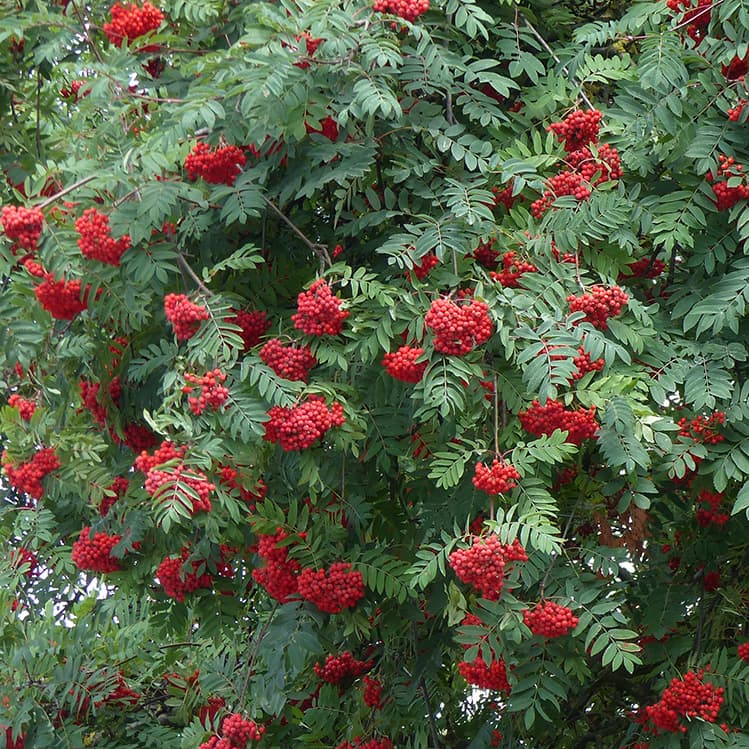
(641, 669), (723, 733)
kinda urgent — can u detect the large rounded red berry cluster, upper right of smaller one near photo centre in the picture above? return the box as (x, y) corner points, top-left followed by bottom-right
(424, 299), (494, 356)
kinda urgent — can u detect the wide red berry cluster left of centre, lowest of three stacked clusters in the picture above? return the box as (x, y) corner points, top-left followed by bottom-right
(265, 395), (346, 452)
